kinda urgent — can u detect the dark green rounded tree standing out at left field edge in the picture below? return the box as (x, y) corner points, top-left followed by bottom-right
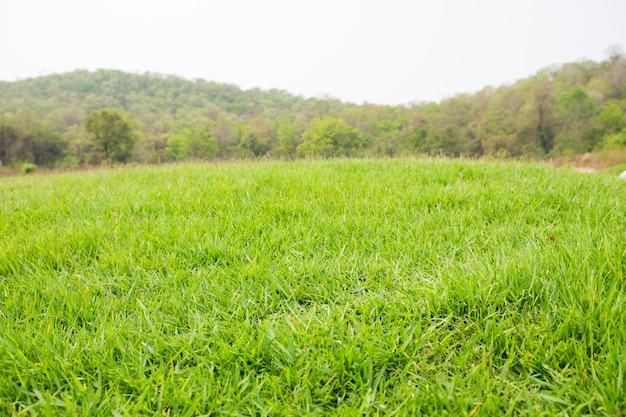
(85, 109), (137, 162)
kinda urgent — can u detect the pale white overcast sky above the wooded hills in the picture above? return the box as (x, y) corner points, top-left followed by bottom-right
(0, 0), (626, 104)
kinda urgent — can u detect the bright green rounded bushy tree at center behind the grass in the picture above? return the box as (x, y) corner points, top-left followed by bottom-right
(297, 117), (365, 157)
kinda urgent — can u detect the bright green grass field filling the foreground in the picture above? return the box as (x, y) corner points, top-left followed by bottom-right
(0, 160), (626, 416)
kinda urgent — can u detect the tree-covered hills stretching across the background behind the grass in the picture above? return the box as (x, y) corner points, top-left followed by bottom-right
(0, 54), (626, 167)
